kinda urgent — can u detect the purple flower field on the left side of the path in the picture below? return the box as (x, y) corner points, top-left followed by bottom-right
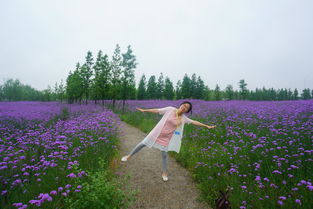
(0, 102), (120, 208)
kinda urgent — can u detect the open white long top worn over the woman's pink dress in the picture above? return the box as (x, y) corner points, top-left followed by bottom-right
(142, 106), (193, 153)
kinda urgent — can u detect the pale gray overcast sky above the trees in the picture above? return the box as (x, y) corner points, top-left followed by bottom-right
(0, 0), (313, 91)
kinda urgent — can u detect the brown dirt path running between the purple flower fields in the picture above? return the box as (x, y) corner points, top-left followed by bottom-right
(116, 122), (211, 209)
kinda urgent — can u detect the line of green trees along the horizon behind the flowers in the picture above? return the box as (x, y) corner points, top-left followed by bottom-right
(0, 44), (313, 103)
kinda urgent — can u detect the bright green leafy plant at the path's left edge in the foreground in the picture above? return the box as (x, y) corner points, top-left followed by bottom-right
(64, 158), (137, 209)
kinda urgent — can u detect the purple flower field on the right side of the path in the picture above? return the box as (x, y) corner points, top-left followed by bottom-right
(113, 100), (313, 209)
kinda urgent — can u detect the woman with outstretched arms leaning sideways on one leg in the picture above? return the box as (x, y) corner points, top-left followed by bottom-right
(121, 101), (215, 181)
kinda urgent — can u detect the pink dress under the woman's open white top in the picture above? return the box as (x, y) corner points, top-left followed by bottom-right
(152, 110), (181, 152)
